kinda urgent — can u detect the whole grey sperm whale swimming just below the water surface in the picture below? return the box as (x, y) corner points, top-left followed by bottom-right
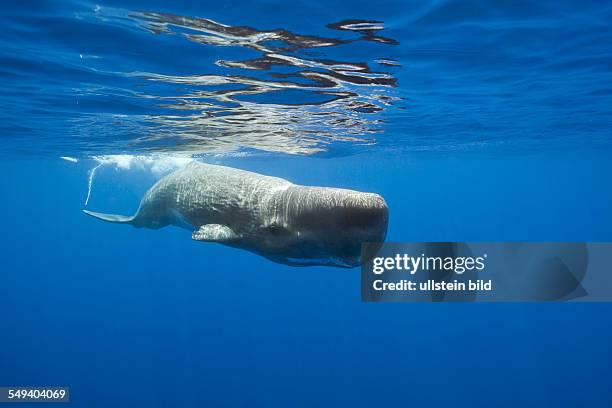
(83, 162), (388, 267)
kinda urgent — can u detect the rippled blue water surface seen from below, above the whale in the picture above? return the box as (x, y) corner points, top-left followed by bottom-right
(0, 1), (612, 156)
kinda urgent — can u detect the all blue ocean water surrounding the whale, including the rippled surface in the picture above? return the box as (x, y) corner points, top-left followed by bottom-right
(0, 0), (612, 407)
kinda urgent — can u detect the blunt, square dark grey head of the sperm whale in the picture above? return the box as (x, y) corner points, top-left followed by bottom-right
(258, 186), (389, 267)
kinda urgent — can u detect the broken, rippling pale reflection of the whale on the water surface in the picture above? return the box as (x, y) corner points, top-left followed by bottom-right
(73, 9), (399, 154)
